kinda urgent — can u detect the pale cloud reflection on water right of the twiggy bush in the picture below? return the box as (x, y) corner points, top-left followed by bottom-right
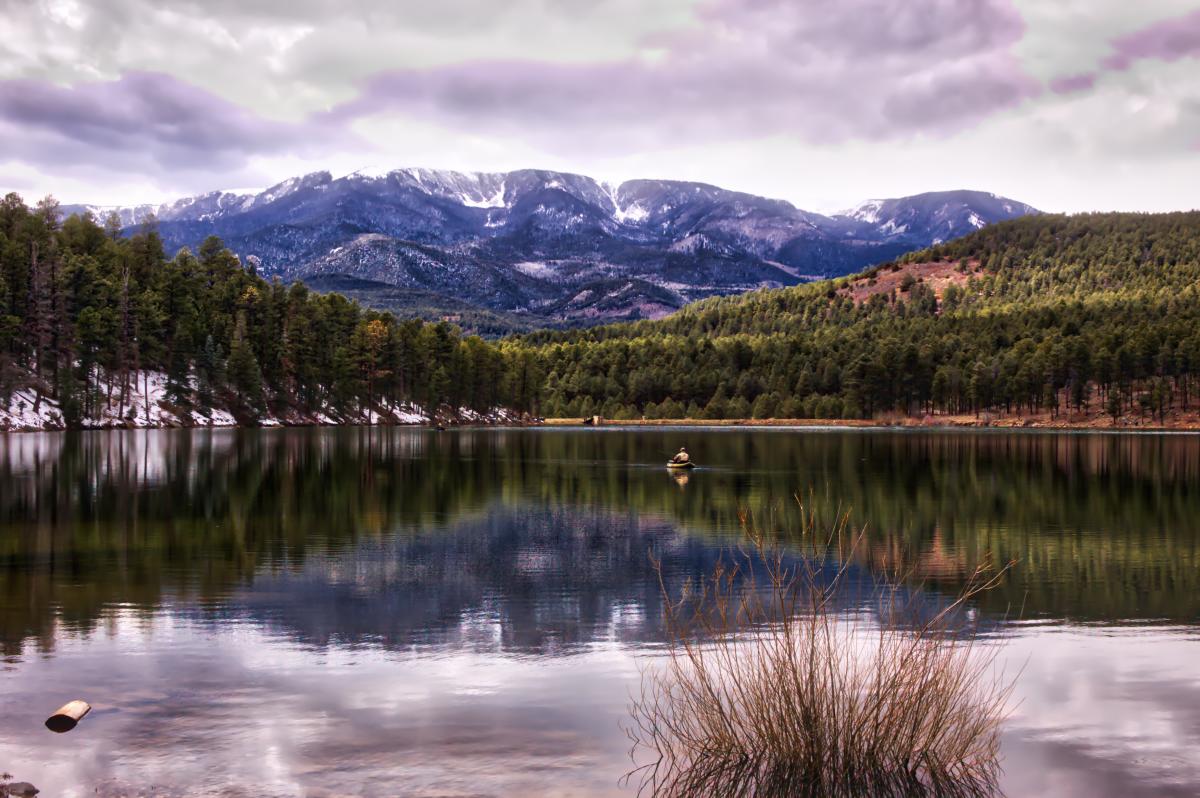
(1002, 626), (1200, 798)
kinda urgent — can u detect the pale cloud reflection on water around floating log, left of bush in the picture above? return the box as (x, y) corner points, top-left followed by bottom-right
(0, 611), (637, 797)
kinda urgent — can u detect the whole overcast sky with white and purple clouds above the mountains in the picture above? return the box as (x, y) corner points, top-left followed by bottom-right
(0, 0), (1200, 211)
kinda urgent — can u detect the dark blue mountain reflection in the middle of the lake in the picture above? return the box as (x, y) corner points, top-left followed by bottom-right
(211, 505), (718, 656)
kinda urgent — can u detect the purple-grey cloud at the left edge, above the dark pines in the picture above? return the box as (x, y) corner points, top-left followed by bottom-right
(0, 72), (337, 174)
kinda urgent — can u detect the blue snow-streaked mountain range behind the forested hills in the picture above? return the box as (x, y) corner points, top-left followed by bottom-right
(64, 169), (1037, 322)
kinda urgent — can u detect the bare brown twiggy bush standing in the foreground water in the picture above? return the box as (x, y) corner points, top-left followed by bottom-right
(626, 508), (1013, 797)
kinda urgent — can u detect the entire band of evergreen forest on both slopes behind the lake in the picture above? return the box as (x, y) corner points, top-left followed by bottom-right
(0, 193), (1200, 430)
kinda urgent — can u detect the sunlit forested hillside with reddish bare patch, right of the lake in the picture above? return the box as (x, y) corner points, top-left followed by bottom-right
(523, 212), (1200, 421)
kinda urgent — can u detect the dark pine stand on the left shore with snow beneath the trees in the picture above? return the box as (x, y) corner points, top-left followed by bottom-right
(0, 194), (538, 427)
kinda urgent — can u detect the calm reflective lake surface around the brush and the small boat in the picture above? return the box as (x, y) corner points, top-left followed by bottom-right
(0, 428), (1200, 797)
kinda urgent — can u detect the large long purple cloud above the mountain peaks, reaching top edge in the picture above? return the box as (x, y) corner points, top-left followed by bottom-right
(328, 0), (1040, 151)
